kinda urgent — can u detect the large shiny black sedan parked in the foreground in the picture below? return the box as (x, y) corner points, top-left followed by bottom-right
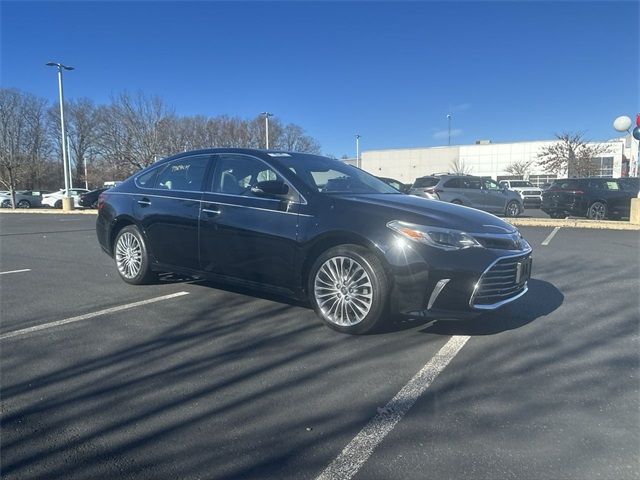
(96, 149), (531, 333)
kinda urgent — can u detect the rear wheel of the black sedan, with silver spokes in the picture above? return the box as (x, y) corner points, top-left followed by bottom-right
(113, 225), (157, 285)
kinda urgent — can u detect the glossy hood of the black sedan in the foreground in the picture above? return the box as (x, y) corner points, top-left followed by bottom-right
(336, 194), (517, 233)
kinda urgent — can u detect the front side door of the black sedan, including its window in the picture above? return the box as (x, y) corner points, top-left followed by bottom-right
(200, 154), (300, 290)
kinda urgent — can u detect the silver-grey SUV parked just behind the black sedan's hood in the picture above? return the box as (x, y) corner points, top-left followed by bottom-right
(411, 174), (524, 217)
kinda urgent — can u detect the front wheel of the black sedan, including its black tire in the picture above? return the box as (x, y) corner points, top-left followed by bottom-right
(307, 245), (389, 335)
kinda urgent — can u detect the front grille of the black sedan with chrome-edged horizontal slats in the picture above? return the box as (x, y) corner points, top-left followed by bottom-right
(470, 254), (531, 308)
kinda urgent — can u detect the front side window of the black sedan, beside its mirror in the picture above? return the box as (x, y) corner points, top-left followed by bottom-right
(211, 154), (280, 197)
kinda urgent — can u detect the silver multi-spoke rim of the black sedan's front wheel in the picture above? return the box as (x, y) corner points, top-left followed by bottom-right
(313, 257), (373, 327)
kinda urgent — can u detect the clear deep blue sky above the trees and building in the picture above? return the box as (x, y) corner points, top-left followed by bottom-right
(0, 1), (640, 157)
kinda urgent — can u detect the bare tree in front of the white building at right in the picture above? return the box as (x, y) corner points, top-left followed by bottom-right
(538, 132), (607, 177)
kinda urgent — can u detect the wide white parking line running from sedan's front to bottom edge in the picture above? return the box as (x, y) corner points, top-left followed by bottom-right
(316, 335), (469, 480)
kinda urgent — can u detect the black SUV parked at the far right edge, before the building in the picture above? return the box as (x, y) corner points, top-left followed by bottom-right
(541, 178), (638, 220)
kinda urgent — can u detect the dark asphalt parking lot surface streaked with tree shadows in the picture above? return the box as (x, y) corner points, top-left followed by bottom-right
(0, 214), (640, 479)
